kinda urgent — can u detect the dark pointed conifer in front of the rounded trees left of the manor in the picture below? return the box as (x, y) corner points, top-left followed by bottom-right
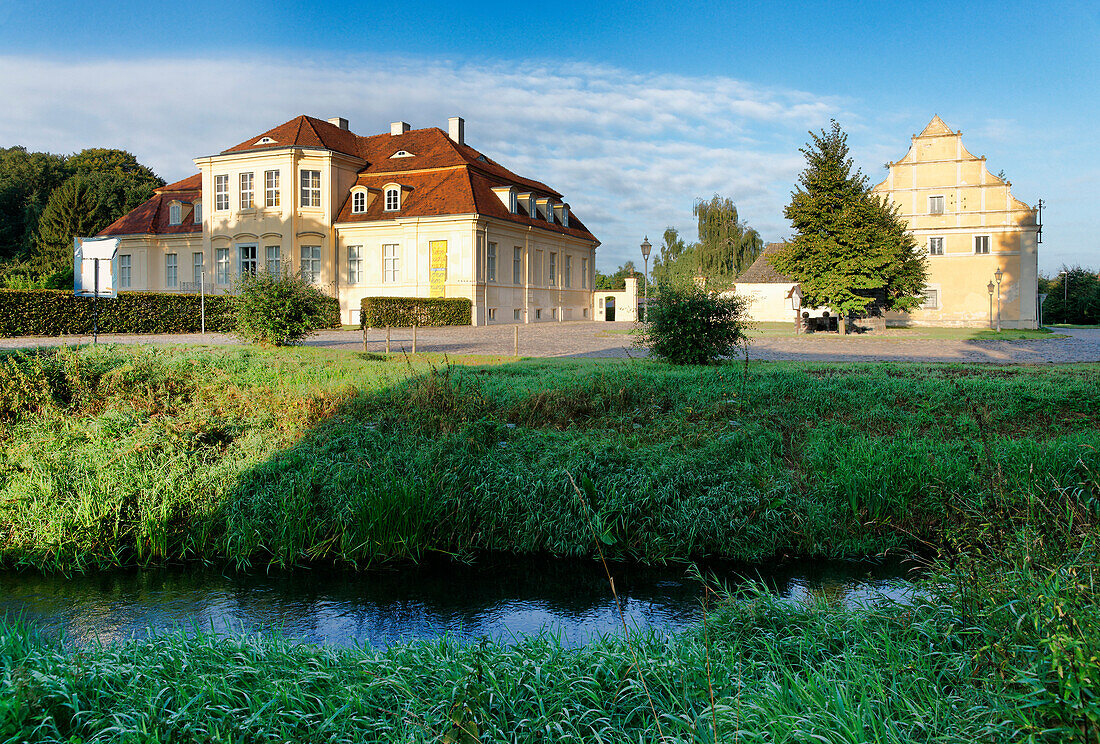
(31, 176), (111, 274)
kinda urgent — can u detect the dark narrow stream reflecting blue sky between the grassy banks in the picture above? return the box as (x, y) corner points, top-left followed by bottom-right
(0, 557), (913, 647)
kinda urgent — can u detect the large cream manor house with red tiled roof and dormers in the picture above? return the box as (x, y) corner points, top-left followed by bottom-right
(100, 116), (600, 325)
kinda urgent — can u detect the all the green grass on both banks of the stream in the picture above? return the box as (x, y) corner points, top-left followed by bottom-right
(0, 347), (1100, 744)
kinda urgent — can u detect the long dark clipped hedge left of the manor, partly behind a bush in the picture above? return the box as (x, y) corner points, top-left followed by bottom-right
(0, 289), (340, 337)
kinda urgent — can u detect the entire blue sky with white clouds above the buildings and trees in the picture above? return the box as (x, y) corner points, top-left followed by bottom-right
(0, 0), (1100, 273)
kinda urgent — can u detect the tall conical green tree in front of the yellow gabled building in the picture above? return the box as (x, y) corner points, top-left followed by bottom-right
(772, 120), (926, 316)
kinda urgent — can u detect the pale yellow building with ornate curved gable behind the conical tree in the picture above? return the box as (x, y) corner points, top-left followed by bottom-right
(875, 116), (1042, 328)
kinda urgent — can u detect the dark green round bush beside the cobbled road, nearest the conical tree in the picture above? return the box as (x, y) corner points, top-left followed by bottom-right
(636, 286), (749, 364)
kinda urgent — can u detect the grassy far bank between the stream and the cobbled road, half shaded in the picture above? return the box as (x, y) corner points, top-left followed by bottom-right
(0, 348), (1100, 569)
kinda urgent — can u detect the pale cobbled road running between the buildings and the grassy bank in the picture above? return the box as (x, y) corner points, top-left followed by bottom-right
(0, 321), (1100, 364)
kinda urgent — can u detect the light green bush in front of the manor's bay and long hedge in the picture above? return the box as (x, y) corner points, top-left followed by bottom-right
(233, 272), (340, 347)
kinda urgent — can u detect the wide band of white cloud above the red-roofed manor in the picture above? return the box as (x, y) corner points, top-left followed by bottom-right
(0, 56), (842, 270)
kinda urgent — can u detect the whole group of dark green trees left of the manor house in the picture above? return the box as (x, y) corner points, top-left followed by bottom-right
(0, 145), (164, 288)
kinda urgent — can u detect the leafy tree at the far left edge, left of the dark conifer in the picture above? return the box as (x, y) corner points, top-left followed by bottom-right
(0, 146), (72, 263)
